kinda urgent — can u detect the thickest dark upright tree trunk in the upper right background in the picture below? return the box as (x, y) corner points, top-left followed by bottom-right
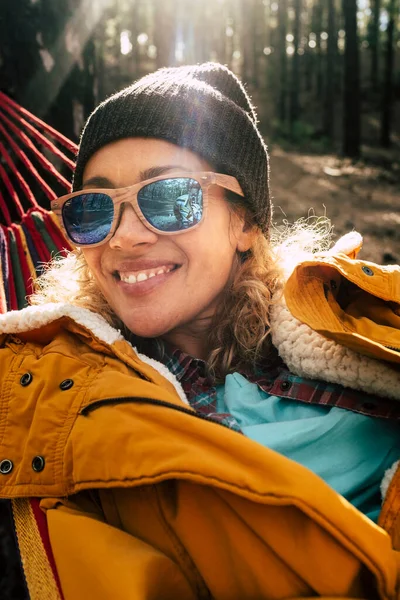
(342, 0), (361, 158)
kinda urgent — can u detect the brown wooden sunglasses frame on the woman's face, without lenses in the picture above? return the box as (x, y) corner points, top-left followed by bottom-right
(51, 171), (244, 248)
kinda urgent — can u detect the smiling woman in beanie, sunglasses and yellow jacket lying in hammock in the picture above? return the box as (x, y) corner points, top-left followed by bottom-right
(0, 64), (400, 600)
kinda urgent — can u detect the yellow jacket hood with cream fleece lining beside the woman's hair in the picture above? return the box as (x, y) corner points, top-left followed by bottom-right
(271, 231), (400, 400)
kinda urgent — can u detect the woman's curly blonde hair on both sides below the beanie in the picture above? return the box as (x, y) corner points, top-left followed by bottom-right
(30, 216), (331, 381)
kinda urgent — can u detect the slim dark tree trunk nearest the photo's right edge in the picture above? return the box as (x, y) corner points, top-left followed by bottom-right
(381, 0), (397, 148)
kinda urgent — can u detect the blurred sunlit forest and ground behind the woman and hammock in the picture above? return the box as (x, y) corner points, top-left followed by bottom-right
(0, 0), (400, 263)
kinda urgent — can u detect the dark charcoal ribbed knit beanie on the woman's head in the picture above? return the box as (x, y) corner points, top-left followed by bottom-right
(73, 63), (271, 234)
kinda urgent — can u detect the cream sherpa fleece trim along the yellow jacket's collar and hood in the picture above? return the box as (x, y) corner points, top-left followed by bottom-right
(0, 298), (400, 403)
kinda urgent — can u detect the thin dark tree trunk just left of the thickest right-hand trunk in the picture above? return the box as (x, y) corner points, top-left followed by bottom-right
(324, 0), (337, 142)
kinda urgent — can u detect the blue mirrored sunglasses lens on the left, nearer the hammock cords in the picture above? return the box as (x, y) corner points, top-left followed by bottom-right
(62, 193), (114, 245)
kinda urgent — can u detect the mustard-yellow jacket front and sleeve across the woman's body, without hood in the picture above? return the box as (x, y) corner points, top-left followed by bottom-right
(0, 241), (400, 600)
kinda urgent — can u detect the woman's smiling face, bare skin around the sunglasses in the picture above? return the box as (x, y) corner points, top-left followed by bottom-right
(79, 138), (250, 343)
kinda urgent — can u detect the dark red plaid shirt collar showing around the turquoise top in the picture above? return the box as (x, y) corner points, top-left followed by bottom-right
(165, 350), (400, 431)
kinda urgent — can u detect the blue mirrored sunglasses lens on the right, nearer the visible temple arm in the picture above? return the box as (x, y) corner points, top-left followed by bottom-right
(138, 177), (203, 232)
